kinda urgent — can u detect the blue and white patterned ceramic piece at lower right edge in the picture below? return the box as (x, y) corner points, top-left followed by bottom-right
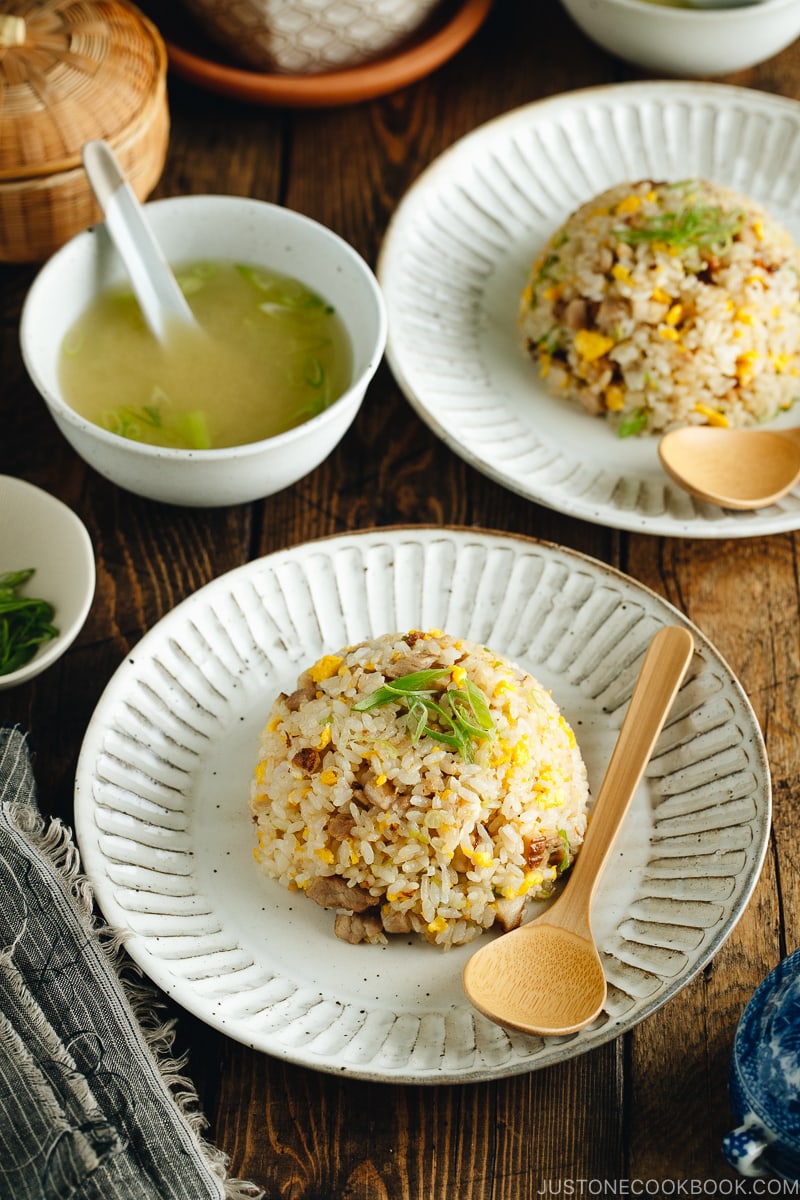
(722, 950), (800, 1180)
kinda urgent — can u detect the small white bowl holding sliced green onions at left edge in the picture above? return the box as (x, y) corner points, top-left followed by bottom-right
(0, 475), (95, 689)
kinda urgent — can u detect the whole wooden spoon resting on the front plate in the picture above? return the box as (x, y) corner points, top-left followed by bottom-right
(463, 625), (694, 1034)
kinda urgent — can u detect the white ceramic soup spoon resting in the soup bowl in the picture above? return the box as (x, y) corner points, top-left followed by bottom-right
(83, 138), (199, 342)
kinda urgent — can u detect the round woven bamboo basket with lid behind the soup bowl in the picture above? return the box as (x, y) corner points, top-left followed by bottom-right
(0, 0), (169, 263)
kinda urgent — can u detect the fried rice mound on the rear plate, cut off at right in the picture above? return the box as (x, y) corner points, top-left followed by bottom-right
(519, 179), (800, 437)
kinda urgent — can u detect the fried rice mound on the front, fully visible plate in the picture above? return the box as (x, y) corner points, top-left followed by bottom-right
(251, 630), (589, 948)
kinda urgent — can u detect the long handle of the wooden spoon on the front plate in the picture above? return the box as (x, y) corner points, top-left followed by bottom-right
(546, 625), (694, 934)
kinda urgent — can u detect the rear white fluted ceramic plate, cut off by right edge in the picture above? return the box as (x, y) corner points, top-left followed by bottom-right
(378, 82), (800, 538)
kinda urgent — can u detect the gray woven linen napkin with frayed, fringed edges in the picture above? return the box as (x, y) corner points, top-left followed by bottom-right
(0, 727), (263, 1200)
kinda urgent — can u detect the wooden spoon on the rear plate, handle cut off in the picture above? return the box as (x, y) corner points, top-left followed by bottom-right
(658, 425), (800, 509)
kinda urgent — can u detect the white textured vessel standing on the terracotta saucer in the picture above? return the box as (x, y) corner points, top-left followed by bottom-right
(178, 0), (443, 74)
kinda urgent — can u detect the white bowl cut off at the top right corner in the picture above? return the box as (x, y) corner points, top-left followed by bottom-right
(561, 0), (800, 77)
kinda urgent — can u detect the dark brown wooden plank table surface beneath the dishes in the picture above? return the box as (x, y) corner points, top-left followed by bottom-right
(0, 0), (800, 1200)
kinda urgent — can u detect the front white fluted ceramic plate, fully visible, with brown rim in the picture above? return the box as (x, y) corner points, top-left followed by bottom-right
(76, 528), (770, 1082)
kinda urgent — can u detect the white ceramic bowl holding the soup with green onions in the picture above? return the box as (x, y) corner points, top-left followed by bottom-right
(20, 196), (386, 508)
